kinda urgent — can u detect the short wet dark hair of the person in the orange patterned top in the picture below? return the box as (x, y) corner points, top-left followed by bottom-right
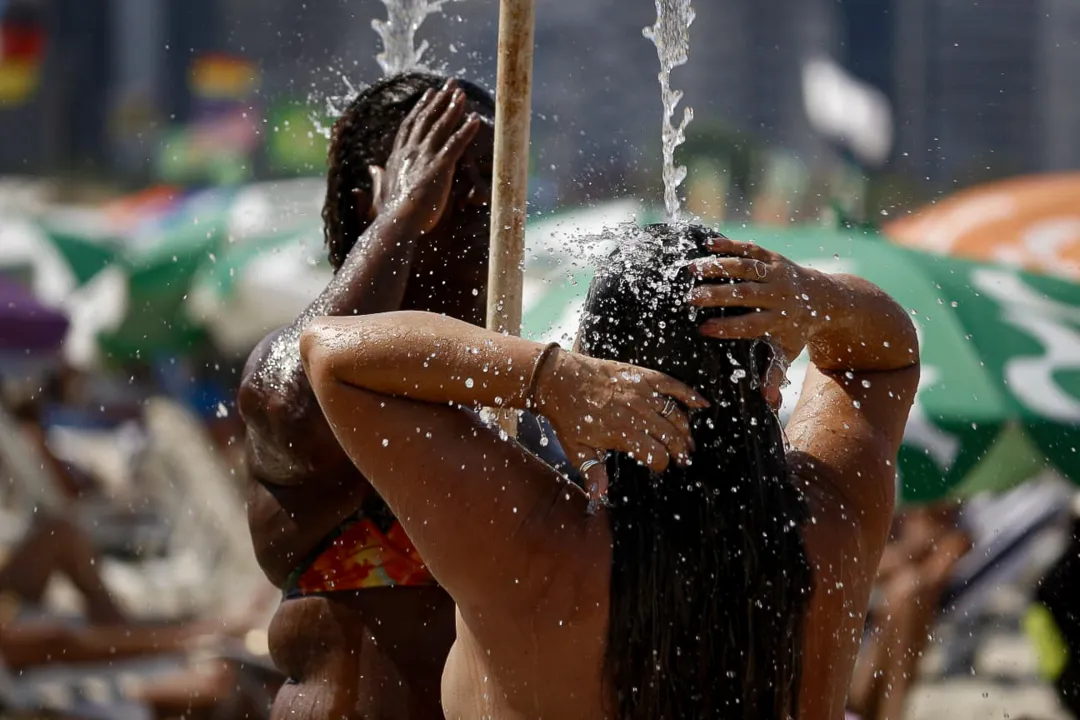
(323, 71), (495, 271)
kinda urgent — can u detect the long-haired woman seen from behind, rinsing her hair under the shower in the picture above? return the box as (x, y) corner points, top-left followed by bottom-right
(301, 226), (918, 720)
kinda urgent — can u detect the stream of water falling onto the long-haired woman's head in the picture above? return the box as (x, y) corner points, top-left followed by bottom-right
(642, 0), (694, 222)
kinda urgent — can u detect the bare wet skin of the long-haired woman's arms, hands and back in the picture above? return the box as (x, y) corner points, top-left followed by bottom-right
(301, 241), (919, 720)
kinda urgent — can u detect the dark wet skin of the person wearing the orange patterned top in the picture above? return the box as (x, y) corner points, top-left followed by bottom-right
(240, 87), (494, 720)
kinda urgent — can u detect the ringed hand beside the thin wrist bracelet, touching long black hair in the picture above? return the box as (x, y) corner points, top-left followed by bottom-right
(535, 352), (708, 499)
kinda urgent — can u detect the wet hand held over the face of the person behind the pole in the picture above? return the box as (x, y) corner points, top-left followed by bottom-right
(368, 80), (481, 234)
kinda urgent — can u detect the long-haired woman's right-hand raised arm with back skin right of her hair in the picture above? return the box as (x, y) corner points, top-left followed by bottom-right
(692, 239), (919, 717)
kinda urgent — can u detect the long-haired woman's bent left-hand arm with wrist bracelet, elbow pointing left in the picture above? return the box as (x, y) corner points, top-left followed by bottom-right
(300, 312), (703, 617)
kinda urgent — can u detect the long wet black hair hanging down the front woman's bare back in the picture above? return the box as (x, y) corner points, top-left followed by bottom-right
(580, 225), (813, 720)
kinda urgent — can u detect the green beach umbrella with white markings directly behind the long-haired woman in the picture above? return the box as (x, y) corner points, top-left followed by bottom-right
(524, 222), (1080, 502)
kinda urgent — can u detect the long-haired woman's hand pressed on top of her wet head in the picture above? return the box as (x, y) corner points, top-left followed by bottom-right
(689, 236), (827, 363)
